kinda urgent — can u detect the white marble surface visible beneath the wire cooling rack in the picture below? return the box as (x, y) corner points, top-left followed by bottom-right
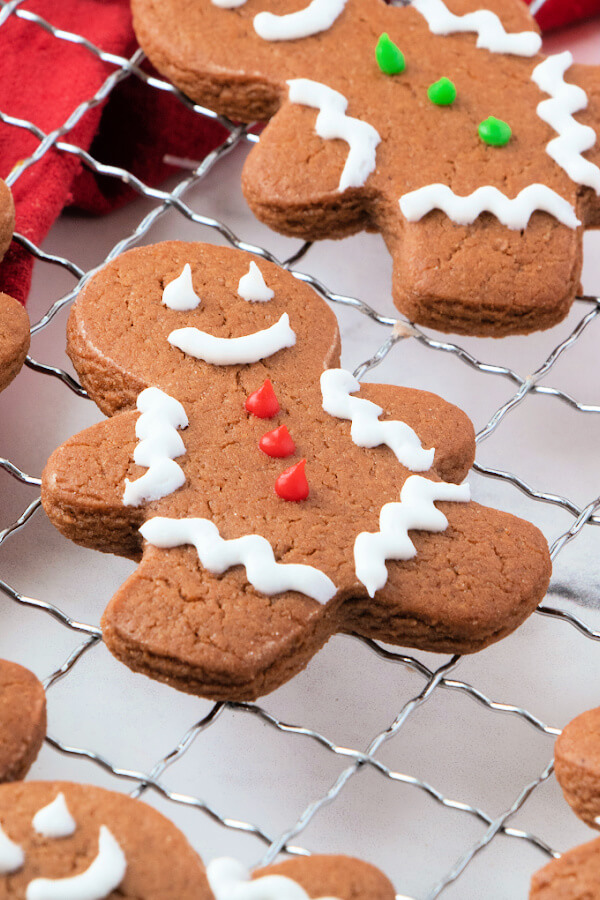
(0, 14), (600, 900)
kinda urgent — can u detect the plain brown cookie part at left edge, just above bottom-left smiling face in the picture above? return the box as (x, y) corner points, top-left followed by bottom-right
(0, 659), (46, 782)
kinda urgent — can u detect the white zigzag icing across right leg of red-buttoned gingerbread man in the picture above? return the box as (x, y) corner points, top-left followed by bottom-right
(354, 475), (471, 597)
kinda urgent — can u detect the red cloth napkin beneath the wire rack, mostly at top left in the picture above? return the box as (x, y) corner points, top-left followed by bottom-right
(0, 0), (600, 302)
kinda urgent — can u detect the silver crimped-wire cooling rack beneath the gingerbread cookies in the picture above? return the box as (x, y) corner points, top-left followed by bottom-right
(0, 0), (600, 900)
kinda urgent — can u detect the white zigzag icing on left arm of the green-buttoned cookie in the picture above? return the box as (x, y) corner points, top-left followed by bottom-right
(288, 78), (381, 191)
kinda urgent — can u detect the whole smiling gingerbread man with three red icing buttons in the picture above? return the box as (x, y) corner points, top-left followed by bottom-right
(42, 242), (550, 700)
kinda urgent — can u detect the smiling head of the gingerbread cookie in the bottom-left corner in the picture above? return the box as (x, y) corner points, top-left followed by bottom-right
(0, 782), (213, 900)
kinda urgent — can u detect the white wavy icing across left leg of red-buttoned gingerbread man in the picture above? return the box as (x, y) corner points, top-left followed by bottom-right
(140, 516), (337, 603)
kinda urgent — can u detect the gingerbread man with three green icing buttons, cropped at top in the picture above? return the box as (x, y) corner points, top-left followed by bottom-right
(132, 0), (600, 336)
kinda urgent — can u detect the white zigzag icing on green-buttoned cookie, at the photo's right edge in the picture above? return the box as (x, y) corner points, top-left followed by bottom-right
(531, 50), (600, 194)
